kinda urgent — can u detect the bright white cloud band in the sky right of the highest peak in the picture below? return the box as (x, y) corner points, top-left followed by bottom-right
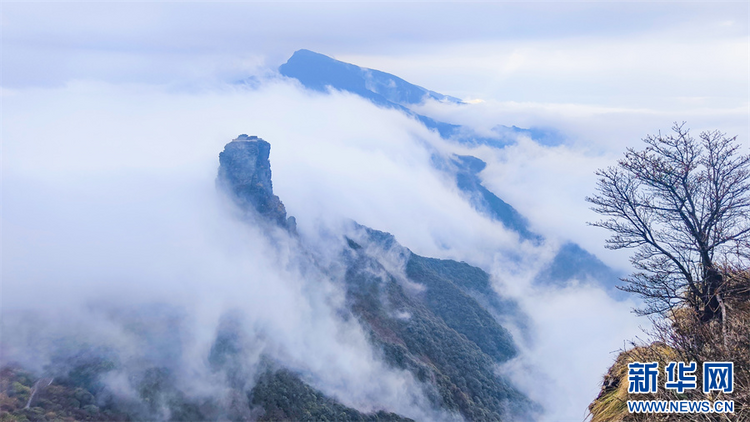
(356, 31), (748, 109)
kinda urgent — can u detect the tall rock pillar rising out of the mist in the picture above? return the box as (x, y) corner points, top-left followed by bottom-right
(217, 135), (296, 232)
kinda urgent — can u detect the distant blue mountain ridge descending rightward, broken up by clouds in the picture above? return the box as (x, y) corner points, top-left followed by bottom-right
(279, 50), (623, 298)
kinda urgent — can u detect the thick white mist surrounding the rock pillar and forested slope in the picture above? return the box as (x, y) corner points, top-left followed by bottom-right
(2, 74), (639, 420)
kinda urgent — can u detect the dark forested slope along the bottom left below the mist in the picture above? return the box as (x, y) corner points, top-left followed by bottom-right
(0, 367), (418, 422)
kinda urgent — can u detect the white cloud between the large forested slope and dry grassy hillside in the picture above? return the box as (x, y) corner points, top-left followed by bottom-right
(501, 286), (641, 422)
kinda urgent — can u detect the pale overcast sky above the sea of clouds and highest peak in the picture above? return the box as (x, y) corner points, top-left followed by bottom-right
(2, 2), (748, 108)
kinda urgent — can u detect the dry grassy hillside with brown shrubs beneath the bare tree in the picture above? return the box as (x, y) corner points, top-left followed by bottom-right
(589, 271), (750, 422)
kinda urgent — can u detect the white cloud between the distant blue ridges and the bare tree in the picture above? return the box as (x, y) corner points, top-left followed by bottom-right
(408, 97), (750, 272)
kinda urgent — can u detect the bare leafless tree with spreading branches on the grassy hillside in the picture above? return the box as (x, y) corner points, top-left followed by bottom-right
(586, 122), (750, 322)
